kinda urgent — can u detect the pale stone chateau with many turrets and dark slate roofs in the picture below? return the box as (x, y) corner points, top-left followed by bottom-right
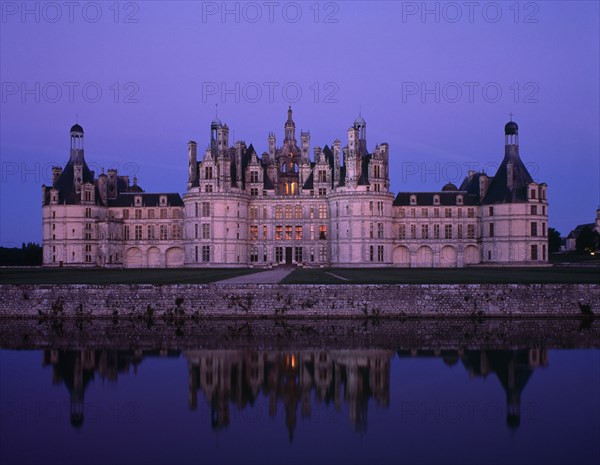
(42, 107), (548, 268)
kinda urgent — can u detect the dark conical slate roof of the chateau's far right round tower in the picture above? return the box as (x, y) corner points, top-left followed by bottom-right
(483, 150), (533, 205)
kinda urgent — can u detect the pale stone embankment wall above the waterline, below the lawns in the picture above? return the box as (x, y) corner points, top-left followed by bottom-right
(0, 284), (600, 319)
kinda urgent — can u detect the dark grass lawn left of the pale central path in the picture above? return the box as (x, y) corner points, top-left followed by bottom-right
(0, 268), (256, 284)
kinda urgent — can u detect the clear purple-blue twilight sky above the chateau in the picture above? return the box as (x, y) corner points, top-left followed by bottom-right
(0, 1), (600, 246)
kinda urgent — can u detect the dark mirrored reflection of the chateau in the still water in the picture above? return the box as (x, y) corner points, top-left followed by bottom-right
(43, 348), (548, 440)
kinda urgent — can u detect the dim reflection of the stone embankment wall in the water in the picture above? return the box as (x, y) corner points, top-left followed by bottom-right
(0, 316), (600, 351)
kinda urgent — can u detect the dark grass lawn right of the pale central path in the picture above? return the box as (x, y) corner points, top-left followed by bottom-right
(282, 267), (600, 284)
